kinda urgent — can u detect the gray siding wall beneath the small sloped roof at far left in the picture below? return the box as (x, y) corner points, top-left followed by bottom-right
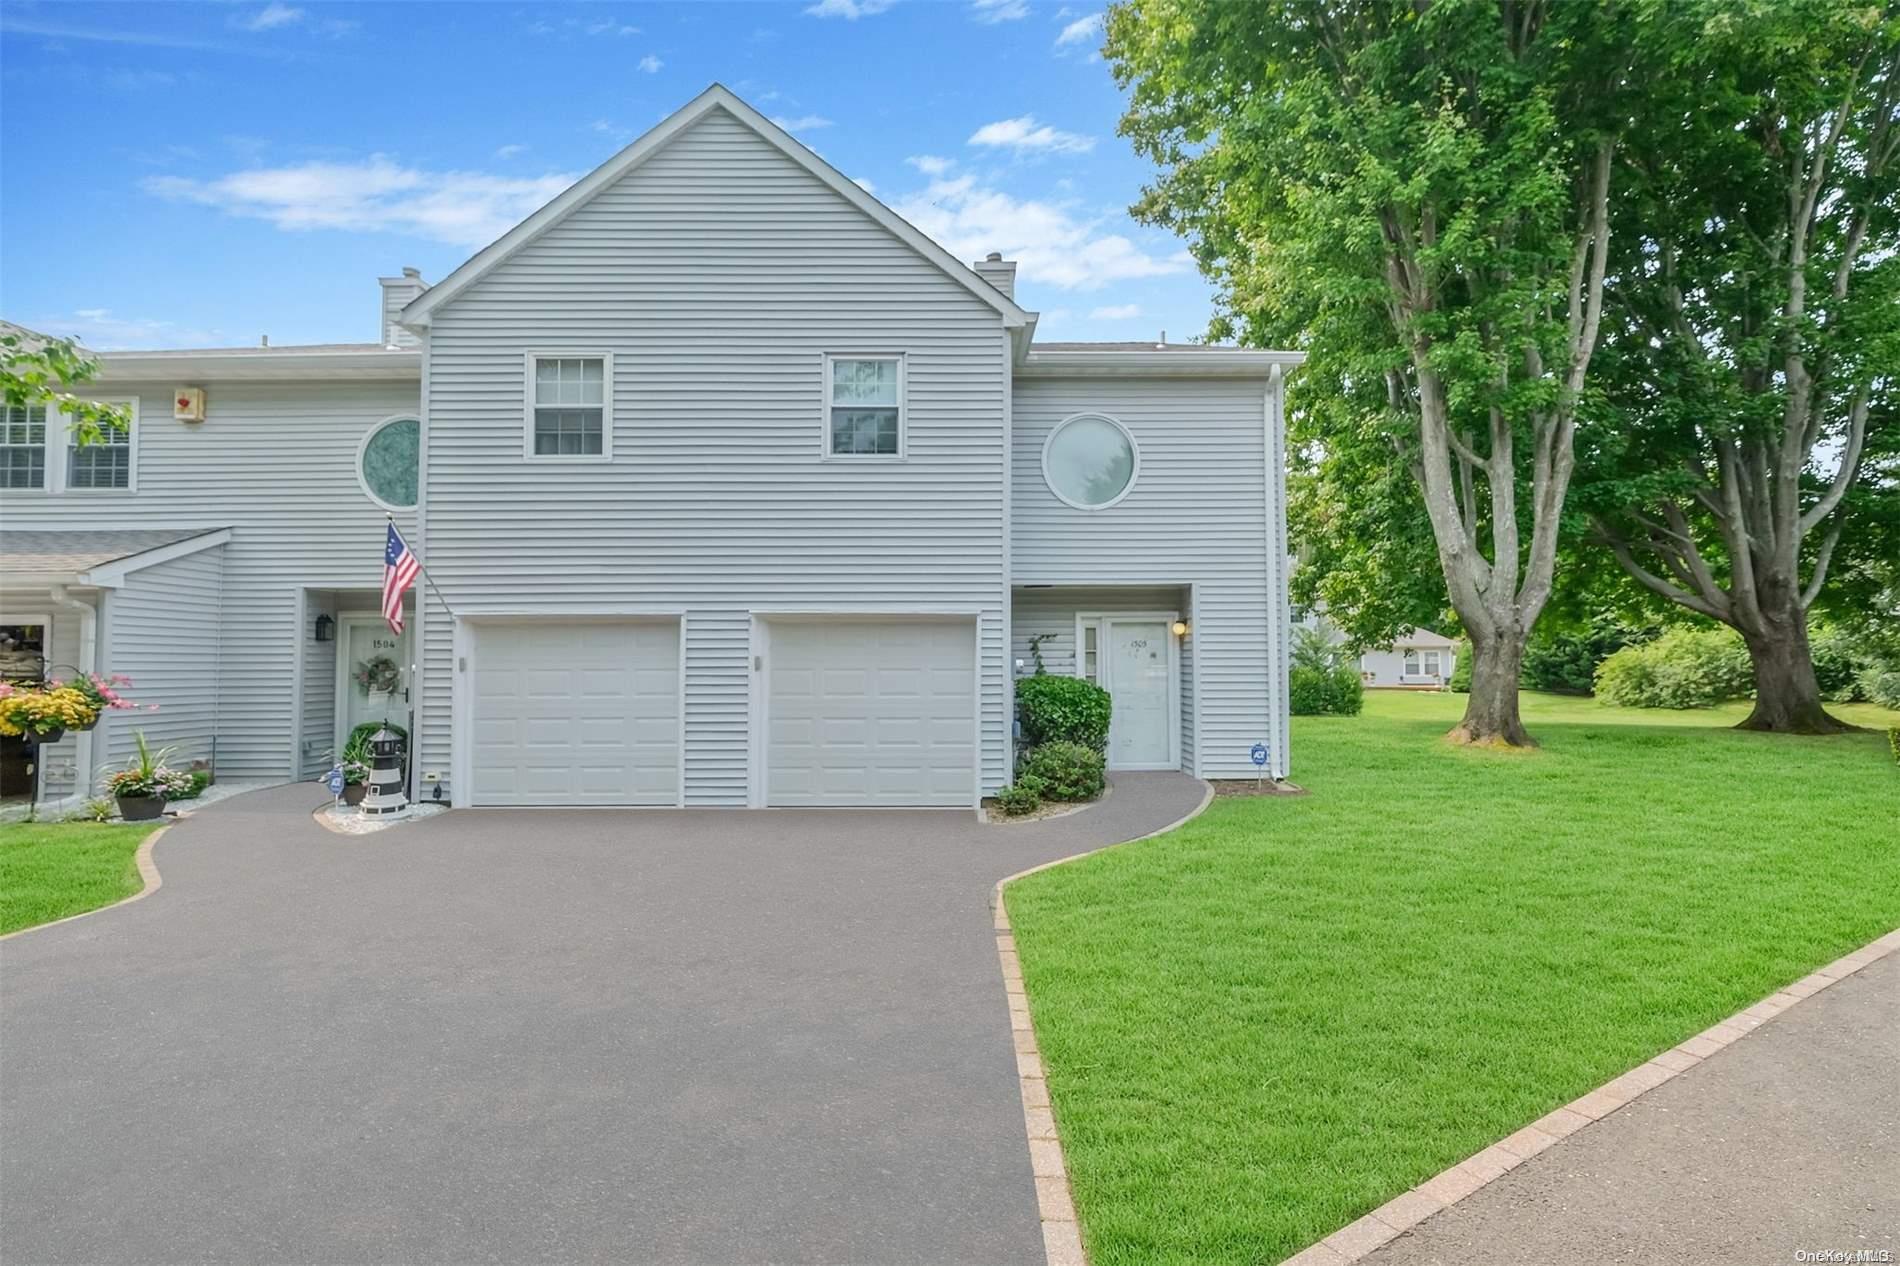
(93, 546), (226, 772)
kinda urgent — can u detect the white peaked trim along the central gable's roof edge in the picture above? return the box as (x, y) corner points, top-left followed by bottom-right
(399, 84), (1036, 338)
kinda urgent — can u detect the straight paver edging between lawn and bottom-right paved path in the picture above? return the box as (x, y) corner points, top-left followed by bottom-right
(1281, 928), (1900, 1266)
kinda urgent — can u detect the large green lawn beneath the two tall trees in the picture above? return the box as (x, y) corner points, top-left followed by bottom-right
(1009, 692), (1900, 1266)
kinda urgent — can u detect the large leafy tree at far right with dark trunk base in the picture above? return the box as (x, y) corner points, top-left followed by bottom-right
(1583, 0), (1900, 734)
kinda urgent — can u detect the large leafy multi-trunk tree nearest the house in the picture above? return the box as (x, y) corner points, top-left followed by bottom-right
(1108, 0), (1638, 745)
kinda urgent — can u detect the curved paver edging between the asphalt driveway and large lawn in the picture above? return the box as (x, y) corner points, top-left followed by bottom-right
(990, 779), (1214, 1266)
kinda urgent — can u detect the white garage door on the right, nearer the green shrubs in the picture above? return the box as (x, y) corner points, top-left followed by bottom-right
(766, 620), (977, 806)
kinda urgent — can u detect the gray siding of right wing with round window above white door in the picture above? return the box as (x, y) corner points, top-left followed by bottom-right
(1011, 370), (1286, 777)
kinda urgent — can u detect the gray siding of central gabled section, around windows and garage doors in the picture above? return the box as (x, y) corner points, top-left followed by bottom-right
(420, 110), (1007, 804)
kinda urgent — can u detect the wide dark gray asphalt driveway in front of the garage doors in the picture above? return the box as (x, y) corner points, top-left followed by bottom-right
(0, 774), (1203, 1264)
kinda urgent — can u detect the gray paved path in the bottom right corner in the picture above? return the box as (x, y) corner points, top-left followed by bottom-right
(1362, 954), (1900, 1266)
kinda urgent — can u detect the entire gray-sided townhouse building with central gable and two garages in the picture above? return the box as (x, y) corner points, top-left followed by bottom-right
(0, 86), (1300, 808)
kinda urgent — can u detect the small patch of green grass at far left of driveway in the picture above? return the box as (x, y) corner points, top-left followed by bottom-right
(0, 821), (154, 933)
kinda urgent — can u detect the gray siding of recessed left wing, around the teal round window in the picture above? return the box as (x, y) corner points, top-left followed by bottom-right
(4, 380), (420, 777)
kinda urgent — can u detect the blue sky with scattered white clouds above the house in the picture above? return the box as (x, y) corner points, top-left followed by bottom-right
(0, 0), (1210, 350)
